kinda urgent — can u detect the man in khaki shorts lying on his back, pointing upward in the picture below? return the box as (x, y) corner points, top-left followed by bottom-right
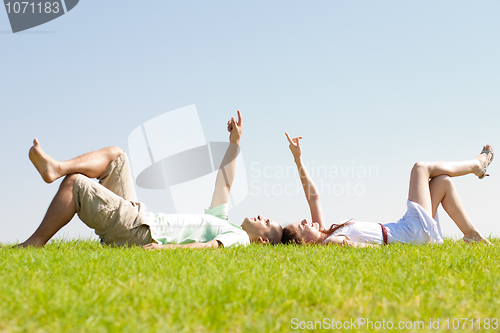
(19, 111), (282, 249)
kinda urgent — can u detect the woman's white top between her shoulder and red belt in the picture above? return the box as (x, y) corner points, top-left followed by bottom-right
(324, 221), (384, 244)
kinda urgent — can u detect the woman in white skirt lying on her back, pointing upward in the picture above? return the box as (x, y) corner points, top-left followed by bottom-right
(281, 133), (493, 247)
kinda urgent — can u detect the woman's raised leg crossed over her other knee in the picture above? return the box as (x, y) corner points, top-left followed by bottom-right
(408, 146), (491, 214)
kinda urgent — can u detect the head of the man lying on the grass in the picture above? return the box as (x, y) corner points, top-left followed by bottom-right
(241, 215), (283, 245)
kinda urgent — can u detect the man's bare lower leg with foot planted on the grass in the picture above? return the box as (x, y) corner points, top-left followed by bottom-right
(19, 175), (77, 247)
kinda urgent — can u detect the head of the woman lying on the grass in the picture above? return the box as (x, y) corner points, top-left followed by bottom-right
(281, 219), (327, 244)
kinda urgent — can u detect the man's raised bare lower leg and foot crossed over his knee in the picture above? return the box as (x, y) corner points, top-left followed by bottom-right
(29, 139), (123, 183)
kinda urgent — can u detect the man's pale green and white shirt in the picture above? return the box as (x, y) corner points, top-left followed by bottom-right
(147, 204), (250, 247)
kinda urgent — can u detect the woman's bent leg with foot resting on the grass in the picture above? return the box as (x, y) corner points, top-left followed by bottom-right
(429, 175), (490, 244)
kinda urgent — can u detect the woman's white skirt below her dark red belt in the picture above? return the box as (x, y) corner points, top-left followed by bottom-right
(384, 200), (443, 244)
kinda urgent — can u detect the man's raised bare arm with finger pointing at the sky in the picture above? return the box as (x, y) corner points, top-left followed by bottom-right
(210, 111), (243, 208)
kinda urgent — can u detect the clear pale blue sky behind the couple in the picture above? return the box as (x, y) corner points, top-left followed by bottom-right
(0, 0), (500, 242)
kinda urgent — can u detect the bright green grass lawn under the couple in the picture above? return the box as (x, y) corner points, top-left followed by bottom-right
(0, 239), (500, 332)
